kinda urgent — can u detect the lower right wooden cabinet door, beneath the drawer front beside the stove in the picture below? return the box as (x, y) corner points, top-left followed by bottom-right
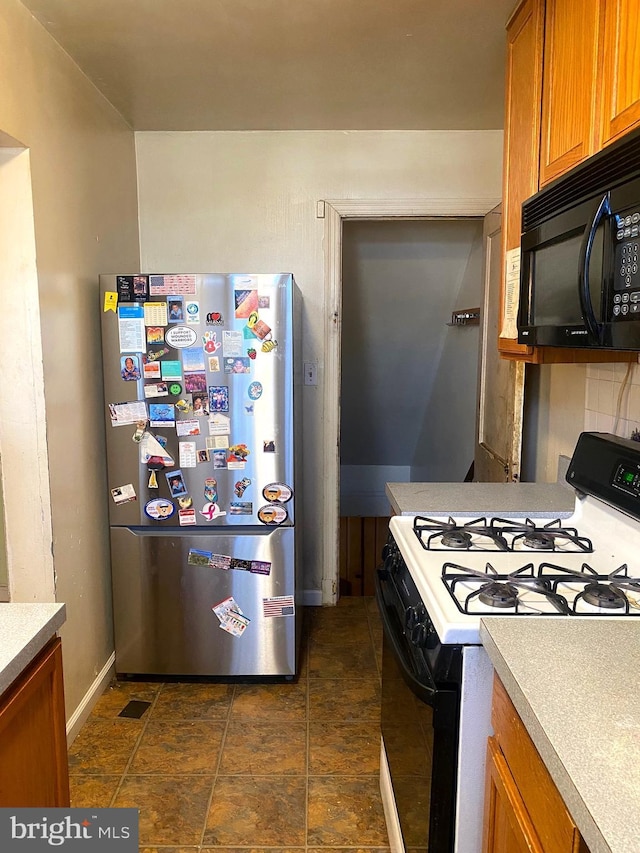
(482, 737), (544, 853)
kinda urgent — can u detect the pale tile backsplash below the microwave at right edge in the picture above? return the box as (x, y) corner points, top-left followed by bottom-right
(584, 363), (640, 438)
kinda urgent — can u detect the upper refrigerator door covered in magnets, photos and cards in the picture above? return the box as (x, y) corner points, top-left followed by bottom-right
(100, 274), (295, 529)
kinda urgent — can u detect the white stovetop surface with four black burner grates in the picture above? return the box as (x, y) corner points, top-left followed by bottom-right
(389, 492), (640, 644)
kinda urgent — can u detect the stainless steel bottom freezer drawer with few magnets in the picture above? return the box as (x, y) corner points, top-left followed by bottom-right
(111, 527), (302, 677)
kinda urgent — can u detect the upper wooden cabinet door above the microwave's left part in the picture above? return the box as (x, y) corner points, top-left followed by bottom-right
(540, 0), (600, 186)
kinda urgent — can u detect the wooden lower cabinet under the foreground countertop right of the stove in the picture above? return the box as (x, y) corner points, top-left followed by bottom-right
(483, 676), (589, 853)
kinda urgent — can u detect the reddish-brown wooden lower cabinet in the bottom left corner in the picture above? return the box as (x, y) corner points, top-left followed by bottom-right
(0, 637), (69, 808)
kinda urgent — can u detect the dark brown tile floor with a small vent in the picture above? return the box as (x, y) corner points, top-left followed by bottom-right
(69, 598), (389, 853)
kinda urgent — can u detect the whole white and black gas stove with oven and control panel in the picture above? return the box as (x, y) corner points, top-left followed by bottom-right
(376, 433), (640, 853)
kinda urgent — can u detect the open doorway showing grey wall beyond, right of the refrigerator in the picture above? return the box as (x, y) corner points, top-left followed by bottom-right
(340, 218), (483, 595)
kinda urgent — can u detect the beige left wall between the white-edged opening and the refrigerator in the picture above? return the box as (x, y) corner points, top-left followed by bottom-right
(0, 0), (139, 715)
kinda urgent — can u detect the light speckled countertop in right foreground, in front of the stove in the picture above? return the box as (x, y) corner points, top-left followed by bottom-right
(480, 617), (640, 853)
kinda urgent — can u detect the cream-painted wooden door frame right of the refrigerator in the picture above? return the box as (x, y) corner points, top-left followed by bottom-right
(318, 196), (500, 604)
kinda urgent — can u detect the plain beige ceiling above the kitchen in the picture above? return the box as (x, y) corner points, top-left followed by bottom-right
(22, 0), (515, 131)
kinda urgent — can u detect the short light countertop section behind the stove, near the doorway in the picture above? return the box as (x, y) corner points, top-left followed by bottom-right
(386, 483), (575, 518)
